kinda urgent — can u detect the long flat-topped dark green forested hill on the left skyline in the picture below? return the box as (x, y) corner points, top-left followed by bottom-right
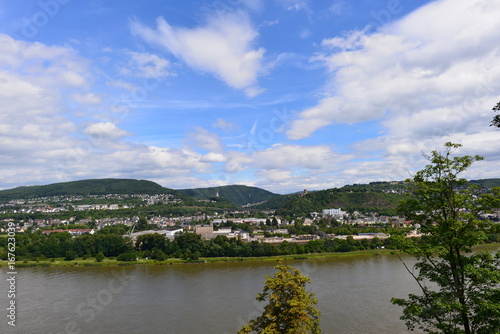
(0, 179), (177, 200)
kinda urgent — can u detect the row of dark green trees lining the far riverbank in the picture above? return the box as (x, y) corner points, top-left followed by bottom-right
(0, 227), (391, 261)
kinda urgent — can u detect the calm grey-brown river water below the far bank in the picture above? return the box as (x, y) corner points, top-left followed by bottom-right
(0, 255), (424, 334)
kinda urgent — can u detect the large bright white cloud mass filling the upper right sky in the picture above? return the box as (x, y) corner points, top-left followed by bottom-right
(287, 0), (500, 145)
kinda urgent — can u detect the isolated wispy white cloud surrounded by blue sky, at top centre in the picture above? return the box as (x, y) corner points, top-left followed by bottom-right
(131, 12), (264, 96)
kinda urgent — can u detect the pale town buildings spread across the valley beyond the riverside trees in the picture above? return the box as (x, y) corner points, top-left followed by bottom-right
(0, 194), (418, 243)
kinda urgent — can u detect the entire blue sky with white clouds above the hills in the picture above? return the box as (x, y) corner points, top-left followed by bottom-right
(0, 0), (500, 193)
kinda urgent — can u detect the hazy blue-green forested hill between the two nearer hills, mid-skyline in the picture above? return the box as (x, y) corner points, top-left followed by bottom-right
(180, 185), (279, 206)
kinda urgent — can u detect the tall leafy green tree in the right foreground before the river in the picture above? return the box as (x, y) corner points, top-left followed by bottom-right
(391, 143), (500, 334)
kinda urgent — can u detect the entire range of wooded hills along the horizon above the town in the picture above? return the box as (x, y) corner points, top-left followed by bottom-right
(0, 178), (500, 211)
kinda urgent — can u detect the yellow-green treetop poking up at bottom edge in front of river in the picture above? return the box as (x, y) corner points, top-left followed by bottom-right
(238, 265), (321, 334)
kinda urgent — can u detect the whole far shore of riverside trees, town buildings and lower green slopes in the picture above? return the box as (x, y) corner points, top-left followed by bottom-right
(0, 181), (500, 261)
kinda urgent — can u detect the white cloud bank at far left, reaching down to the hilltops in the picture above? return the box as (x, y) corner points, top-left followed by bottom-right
(0, 35), (215, 188)
